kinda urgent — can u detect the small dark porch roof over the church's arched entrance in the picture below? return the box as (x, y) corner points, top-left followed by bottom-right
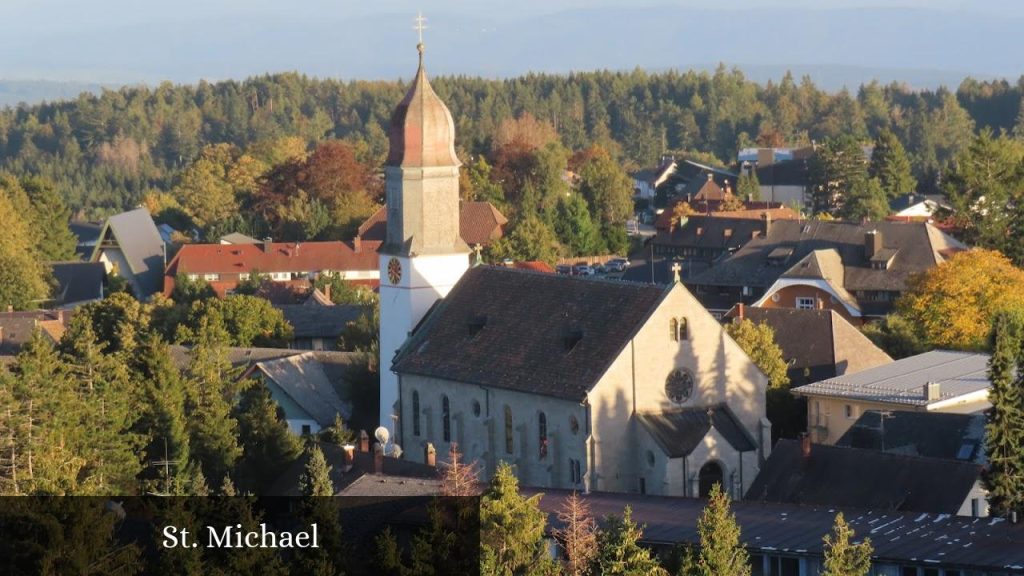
(637, 404), (757, 458)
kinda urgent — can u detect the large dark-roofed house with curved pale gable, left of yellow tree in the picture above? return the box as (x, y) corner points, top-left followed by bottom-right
(687, 220), (967, 323)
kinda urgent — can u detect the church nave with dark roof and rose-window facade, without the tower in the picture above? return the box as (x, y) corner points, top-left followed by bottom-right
(391, 265), (771, 496)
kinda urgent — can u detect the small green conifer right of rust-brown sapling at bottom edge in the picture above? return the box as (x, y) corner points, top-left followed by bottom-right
(592, 506), (666, 576)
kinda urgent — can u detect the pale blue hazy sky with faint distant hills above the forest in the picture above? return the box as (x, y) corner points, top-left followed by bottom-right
(0, 0), (1024, 82)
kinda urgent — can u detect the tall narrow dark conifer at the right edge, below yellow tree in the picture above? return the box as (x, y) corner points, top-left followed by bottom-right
(982, 310), (1024, 516)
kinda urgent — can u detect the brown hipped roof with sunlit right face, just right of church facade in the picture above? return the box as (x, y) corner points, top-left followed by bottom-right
(727, 306), (893, 385)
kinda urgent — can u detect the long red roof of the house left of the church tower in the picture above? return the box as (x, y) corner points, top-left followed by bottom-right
(167, 241), (379, 277)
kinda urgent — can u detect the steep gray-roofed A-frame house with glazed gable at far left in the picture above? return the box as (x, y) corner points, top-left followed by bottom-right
(89, 208), (166, 300)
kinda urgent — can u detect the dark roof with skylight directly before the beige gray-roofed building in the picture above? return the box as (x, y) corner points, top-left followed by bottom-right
(836, 410), (986, 464)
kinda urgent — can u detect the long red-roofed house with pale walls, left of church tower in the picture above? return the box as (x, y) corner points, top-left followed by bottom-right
(164, 239), (380, 295)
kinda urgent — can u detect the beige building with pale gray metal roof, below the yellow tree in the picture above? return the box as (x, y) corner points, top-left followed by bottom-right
(793, 351), (991, 444)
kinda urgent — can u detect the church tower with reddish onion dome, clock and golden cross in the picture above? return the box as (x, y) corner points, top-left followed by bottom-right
(380, 36), (470, 430)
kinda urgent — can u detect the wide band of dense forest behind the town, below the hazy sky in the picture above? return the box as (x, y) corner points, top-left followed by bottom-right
(0, 67), (1024, 218)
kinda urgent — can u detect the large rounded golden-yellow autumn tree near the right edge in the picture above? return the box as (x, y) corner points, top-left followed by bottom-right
(896, 248), (1024, 349)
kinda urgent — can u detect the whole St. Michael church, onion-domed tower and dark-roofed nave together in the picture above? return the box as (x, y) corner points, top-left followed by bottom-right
(380, 43), (771, 498)
